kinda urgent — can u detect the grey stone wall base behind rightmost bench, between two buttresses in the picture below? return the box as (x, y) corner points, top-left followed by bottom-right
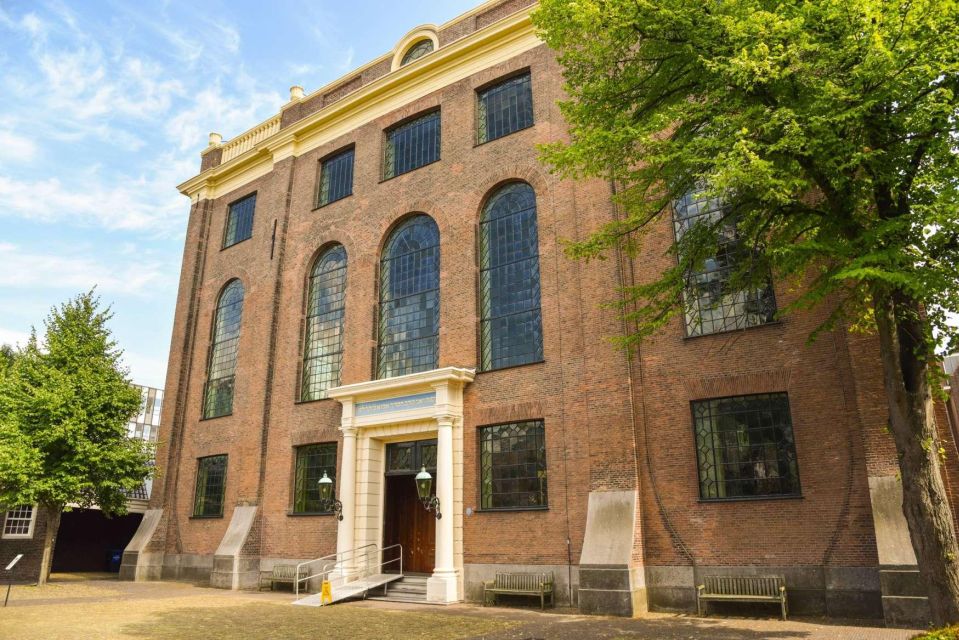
(646, 566), (883, 620)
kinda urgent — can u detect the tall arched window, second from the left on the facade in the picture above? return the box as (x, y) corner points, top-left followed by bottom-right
(300, 244), (346, 401)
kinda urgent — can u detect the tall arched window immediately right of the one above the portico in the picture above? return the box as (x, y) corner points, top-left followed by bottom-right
(480, 182), (543, 371)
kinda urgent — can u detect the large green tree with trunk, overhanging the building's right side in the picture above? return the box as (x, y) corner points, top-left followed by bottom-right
(534, 0), (959, 623)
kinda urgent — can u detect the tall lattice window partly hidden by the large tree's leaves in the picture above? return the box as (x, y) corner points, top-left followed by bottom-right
(673, 191), (776, 336)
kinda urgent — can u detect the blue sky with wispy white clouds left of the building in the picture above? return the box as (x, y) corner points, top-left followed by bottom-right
(0, 0), (479, 387)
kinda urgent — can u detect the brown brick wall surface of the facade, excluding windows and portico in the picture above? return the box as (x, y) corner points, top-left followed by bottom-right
(127, 1), (952, 616)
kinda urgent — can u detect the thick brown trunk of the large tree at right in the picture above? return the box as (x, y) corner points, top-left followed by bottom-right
(875, 294), (959, 626)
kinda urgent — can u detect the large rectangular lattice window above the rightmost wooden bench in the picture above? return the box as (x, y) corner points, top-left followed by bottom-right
(692, 393), (799, 500)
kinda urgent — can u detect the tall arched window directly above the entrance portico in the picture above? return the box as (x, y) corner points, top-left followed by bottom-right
(376, 214), (440, 378)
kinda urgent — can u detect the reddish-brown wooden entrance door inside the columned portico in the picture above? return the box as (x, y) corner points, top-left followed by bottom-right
(383, 475), (436, 573)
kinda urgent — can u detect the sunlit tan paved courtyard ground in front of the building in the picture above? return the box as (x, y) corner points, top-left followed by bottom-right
(0, 575), (928, 640)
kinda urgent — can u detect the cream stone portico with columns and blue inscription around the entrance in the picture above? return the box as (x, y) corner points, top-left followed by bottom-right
(328, 367), (476, 603)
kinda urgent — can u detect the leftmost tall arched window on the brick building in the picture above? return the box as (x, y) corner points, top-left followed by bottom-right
(203, 280), (243, 418)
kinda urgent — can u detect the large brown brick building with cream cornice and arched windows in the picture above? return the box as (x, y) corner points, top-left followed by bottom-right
(121, 0), (956, 620)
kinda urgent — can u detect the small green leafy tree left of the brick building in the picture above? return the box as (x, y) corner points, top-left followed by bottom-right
(0, 291), (151, 584)
